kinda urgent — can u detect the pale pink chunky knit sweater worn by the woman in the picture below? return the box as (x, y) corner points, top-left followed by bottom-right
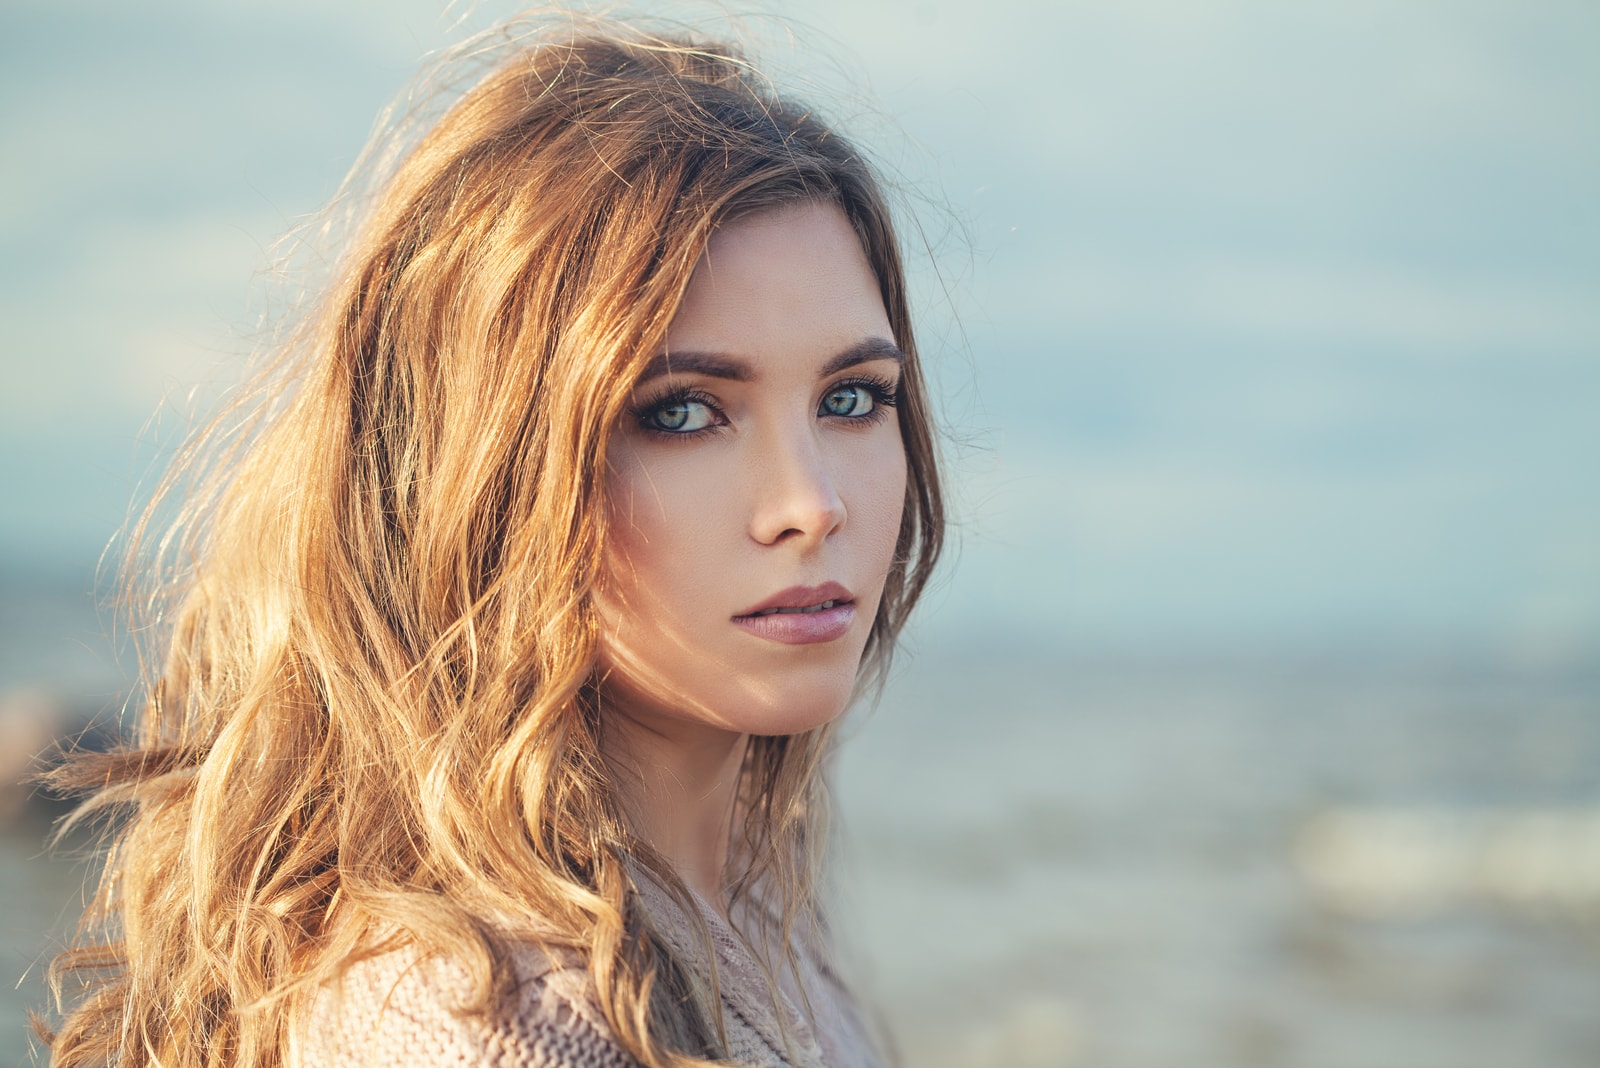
(288, 879), (880, 1068)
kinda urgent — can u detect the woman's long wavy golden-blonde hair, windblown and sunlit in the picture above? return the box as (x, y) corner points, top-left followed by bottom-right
(43, 16), (942, 1068)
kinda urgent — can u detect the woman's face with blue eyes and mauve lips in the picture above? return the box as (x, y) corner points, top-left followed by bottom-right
(598, 201), (906, 734)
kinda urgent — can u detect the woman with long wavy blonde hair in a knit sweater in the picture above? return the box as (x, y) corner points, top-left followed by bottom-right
(43, 16), (942, 1066)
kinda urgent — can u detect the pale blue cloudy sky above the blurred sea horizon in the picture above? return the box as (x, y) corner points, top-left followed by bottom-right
(0, 0), (1600, 681)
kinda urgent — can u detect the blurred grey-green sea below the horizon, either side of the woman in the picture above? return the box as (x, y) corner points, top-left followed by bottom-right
(0, 584), (1600, 1068)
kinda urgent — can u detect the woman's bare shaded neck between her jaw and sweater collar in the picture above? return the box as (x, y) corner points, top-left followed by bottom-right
(602, 707), (749, 911)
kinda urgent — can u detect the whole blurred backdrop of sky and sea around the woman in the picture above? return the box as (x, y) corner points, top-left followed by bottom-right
(0, 0), (1600, 1068)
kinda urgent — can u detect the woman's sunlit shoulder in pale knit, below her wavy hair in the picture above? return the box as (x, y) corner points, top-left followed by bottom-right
(288, 943), (637, 1068)
